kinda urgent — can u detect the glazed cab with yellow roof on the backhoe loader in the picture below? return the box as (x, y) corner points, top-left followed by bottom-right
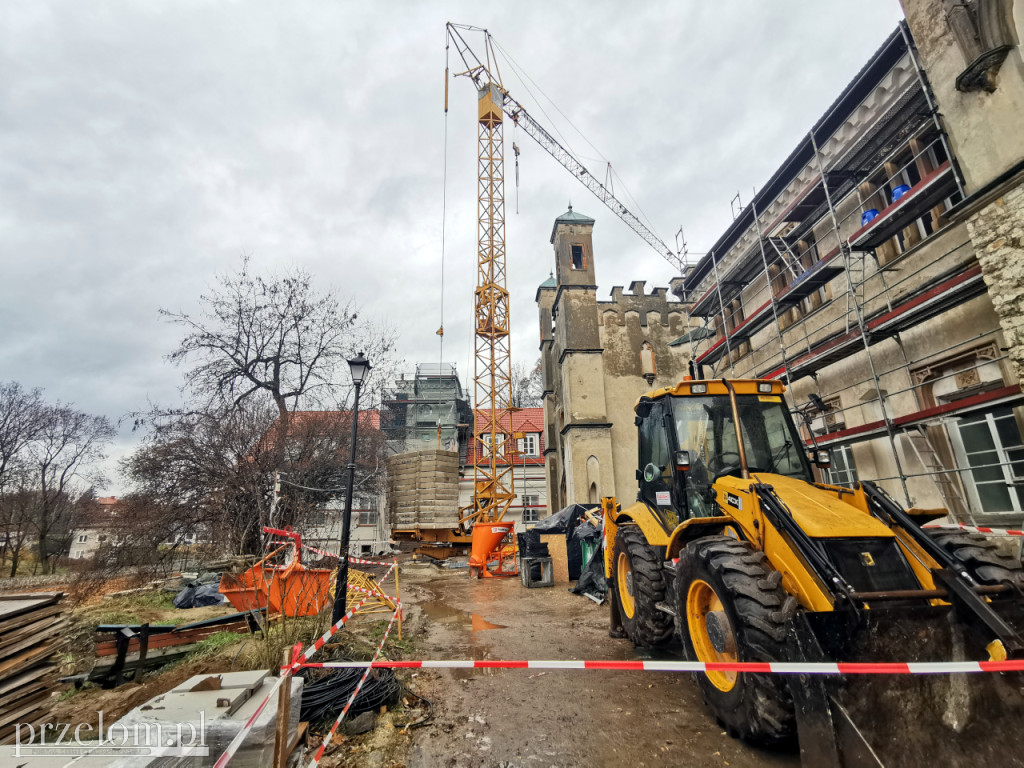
(636, 380), (814, 528)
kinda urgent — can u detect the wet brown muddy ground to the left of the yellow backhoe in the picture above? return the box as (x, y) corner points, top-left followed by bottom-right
(395, 566), (800, 768)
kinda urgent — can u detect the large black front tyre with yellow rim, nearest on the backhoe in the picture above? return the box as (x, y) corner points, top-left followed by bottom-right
(675, 536), (797, 745)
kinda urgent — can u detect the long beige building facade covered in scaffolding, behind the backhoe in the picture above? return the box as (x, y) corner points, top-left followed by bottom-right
(684, 26), (1024, 523)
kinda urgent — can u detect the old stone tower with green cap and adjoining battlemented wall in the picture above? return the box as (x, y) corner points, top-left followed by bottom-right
(537, 208), (689, 512)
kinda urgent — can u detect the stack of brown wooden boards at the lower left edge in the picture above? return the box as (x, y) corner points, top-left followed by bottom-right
(0, 592), (68, 744)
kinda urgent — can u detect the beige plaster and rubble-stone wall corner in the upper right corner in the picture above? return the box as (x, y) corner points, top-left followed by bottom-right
(903, 0), (1024, 379)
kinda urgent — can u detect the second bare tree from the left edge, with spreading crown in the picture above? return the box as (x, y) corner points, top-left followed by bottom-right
(28, 403), (115, 572)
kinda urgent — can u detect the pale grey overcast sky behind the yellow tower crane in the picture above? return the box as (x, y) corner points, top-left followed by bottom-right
(0, 0), (901, 493)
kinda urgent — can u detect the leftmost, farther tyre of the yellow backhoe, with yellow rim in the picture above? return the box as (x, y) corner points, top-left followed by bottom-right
(612, 524), (675, 648)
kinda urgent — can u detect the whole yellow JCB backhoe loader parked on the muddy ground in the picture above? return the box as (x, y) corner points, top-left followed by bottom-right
(602, 377), (1024, 766)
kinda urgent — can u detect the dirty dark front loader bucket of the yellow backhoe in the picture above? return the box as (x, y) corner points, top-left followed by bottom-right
(788, 600), (1024, 768)
